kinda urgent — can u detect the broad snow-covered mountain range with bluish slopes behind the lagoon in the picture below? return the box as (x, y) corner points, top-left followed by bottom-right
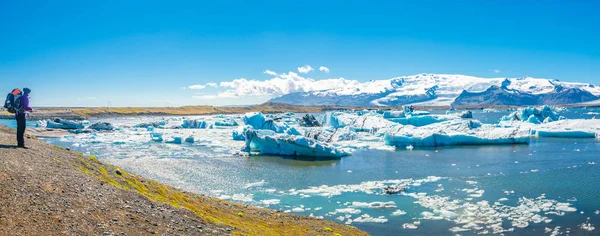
(270, 74), (600, 106)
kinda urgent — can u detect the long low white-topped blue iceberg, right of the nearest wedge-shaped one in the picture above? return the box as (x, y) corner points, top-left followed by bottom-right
(384, 119), (529, 148)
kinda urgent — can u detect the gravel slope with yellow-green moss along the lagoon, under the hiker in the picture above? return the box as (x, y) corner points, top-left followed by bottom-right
(0, 126), (366, 235)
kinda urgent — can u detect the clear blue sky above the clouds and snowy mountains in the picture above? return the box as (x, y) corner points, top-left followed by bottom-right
(0, 0), (600, 106)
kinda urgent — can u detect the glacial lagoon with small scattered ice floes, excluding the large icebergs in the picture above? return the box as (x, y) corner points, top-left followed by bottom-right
(0, 108), (600, 235)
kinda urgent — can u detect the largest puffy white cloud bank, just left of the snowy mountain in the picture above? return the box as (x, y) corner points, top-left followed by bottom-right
(214, 71), (360, 97)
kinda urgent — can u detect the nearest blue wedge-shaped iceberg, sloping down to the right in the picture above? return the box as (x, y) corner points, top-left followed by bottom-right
(245, 129), (350, 158)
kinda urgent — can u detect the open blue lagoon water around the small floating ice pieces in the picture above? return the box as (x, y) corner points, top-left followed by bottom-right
(0, 109), (600, 235)
